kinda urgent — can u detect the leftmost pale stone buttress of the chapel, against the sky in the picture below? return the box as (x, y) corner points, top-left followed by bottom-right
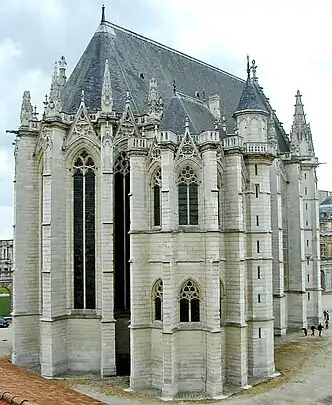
(12, 129), (40, 368)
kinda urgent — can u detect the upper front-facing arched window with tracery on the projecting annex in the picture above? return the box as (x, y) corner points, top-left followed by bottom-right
(178, 166), (198, 225)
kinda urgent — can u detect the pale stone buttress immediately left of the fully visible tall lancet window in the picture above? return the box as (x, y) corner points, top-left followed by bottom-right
(41, 125), (67, 377)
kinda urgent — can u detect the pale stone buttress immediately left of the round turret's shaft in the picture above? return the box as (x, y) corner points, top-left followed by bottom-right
(224, 149), (248, 387)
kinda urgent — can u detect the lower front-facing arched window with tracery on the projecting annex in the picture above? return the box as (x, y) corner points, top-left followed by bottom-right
(180, 280), (200, 322)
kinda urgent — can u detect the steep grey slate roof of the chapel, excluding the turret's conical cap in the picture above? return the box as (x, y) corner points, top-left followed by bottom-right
(62, 21), (289, 151)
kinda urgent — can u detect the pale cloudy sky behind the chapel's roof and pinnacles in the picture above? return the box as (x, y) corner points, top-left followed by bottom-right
(0, 0), (332, 239)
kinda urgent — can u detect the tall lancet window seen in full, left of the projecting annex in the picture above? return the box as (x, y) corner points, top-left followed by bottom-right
(73, 151), (96, 309)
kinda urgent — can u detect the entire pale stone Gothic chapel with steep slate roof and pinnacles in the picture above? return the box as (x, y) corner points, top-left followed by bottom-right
(12, 8), (321, 399)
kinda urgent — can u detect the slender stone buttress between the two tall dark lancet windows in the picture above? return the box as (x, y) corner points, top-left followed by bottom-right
(100, 125), (116, 377)
